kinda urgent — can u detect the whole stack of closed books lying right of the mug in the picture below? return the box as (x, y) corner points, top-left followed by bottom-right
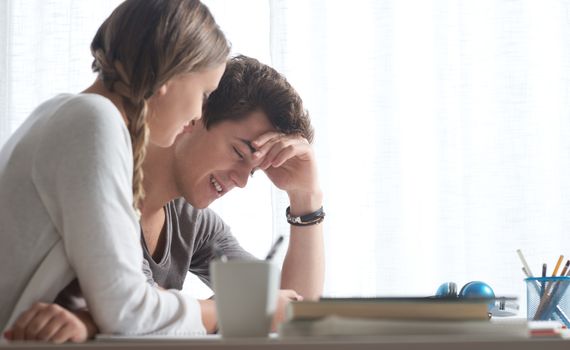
(279, 297), (528, 338)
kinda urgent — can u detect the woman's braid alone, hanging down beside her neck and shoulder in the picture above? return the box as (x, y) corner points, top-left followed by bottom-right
(93, 49), (149, 216)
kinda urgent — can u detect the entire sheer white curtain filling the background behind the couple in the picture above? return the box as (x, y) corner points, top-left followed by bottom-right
(0, 0), (570, 312)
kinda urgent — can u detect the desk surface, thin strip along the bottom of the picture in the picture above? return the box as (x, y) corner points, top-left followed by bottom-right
(0, 336), (570, 350)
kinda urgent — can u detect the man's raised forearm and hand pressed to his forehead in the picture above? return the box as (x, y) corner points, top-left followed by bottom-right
(253, 132), (325, 300)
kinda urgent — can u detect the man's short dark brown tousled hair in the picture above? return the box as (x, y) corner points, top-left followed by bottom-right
(203, 55), (314, 142)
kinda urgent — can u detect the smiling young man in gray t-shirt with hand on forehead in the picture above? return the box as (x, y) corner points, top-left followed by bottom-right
(4, 56), (324, 342)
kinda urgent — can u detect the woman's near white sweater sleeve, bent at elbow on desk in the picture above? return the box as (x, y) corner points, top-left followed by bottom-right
(32, 95), (205, 335)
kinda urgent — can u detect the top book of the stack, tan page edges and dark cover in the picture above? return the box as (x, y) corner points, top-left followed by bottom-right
(287, 297), (493, 321)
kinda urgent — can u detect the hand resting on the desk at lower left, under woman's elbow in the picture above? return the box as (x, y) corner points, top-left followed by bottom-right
(4, 303), (97, 344)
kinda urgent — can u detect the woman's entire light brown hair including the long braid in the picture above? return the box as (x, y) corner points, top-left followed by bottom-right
(91, 0), (230, 209)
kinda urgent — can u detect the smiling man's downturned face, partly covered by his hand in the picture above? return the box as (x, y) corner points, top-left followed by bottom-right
(173, 111), (274, 208)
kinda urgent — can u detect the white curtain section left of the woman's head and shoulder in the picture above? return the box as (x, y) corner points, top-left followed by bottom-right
(0, 0), (120, 146)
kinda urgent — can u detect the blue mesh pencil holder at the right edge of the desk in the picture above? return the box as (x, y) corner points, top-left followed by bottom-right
(525, 277), (570, 327)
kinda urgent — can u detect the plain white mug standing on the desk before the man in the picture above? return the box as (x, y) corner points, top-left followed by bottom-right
(210, 259), (281, 337)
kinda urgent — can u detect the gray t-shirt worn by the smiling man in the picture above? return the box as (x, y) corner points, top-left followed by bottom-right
(141, 198), (255, 289)
